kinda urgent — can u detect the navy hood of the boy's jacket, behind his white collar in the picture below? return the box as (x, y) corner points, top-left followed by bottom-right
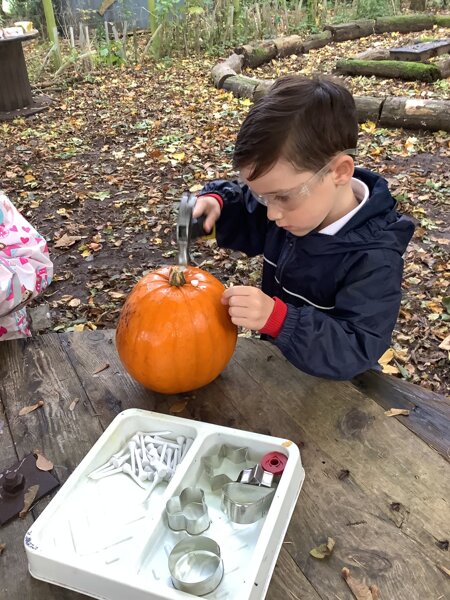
(294, 168), (414, 254)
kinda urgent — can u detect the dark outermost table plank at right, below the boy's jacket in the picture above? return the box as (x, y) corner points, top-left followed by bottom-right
(352, 371), (450, 462)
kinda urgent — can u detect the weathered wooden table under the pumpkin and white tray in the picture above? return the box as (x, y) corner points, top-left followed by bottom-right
(0, 331), (450, 600)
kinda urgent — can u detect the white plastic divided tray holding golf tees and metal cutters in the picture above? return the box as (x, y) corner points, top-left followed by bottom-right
(24, 409), (304, 600)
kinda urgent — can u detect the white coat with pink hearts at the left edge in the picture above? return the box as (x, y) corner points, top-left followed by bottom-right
(0, 191), (53, 342)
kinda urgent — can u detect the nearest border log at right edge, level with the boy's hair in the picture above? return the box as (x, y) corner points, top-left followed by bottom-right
(379, 96), (450, 131)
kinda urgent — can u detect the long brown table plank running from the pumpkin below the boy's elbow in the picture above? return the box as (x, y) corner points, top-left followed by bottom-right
(240, 342), (450, 561)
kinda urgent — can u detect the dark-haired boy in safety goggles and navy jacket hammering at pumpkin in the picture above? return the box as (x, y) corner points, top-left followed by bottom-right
(194, 76), (414, 379)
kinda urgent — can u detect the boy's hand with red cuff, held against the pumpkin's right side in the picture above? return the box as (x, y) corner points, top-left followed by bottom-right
(222, 285), (275, 331)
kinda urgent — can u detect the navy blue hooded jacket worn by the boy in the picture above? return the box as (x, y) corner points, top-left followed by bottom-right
(201, 168), (414, 379)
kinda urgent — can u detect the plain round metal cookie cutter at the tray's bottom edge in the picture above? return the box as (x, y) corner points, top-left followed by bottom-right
(169, 536), (223, 596)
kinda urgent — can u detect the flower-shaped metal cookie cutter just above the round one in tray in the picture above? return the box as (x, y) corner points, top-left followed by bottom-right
(166, 487), (210, 535)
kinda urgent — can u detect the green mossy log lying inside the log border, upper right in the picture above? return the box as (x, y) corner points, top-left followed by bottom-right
(336, 60), (441, 82)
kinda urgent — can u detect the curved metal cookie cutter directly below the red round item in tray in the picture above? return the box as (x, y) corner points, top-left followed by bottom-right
(222, 482), (275, 525)
